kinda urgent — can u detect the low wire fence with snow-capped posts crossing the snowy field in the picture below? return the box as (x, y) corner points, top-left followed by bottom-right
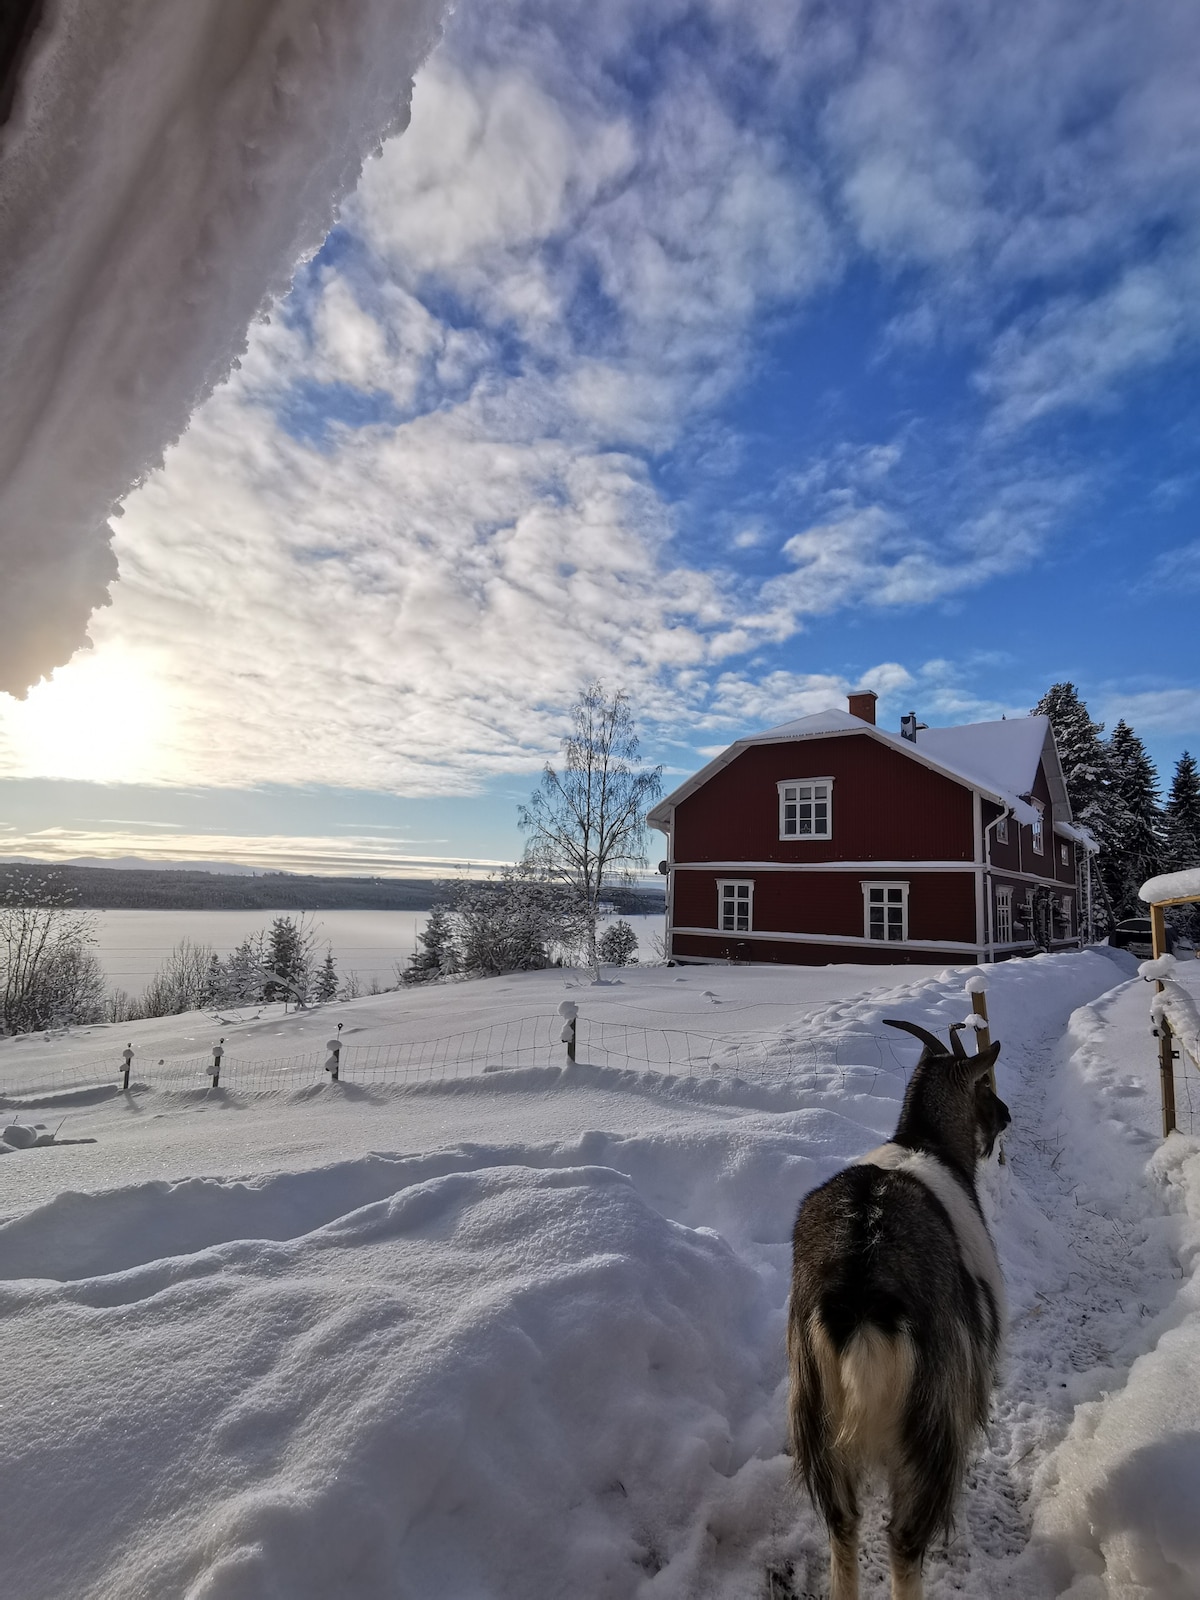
(0, 1013), (907, 1106)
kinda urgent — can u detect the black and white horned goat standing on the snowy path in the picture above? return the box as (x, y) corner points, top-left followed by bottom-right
(787, 1022), (1010, 1600)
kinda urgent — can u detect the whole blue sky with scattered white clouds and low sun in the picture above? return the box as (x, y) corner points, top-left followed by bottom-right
(0, 0), (1200, 870)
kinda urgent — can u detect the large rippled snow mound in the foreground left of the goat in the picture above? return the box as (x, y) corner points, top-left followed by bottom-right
(0, 1168), (765, 1600)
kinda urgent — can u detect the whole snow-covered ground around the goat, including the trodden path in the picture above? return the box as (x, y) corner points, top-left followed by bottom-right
(0, 950), (1200, 1600)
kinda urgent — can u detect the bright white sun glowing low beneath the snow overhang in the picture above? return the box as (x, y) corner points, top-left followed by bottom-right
(0, 650), (168, 784)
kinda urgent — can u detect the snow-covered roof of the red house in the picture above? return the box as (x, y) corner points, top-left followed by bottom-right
(648, 707), (1091, 848)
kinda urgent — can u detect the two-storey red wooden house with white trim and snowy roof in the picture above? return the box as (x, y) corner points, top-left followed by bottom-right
(650, 691), (1094, 966)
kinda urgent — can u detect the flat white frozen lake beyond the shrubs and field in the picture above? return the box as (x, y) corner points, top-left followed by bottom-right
(84, 910), (664, 995)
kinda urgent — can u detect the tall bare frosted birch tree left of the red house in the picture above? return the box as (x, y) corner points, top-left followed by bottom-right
(517, 683), (662, 966)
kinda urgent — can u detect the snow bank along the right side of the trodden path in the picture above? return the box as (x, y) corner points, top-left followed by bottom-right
(1032, 960), (1200, 1600)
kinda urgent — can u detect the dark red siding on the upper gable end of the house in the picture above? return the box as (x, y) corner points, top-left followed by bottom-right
(674, 733), (974, 864)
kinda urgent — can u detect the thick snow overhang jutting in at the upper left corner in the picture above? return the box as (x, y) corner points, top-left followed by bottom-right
(0, 0), (443, 694)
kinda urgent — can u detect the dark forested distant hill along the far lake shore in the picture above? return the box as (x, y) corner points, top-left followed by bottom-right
(0, 862), (666, 917)
